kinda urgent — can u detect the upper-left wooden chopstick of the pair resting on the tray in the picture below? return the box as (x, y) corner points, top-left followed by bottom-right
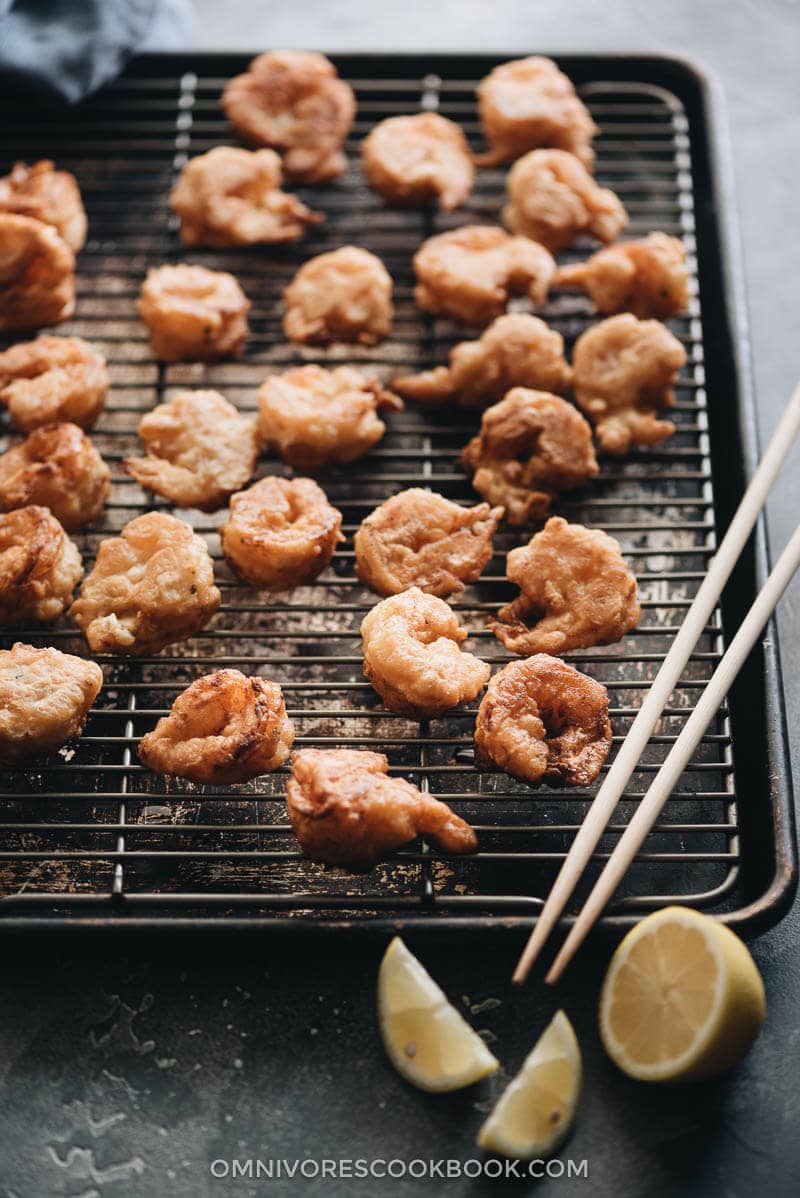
(513, 385), (800, 982)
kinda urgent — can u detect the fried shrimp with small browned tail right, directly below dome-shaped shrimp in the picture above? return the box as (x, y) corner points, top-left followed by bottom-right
(259, 367), (402, 470)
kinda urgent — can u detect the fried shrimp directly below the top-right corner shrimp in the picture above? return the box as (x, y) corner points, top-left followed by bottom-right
(503, 150), (628, 254)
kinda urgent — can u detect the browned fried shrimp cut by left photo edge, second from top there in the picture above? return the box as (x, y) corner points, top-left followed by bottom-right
(0, 212), (75, 331)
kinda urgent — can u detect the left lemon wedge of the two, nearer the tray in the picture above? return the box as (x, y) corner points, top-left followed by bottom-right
(377, 936), (498, 1091)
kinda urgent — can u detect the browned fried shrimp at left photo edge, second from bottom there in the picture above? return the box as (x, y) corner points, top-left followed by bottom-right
(0, 504), (84, 624)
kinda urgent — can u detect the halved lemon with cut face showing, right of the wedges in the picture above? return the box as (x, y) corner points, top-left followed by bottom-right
(600, 907), (765, 1082)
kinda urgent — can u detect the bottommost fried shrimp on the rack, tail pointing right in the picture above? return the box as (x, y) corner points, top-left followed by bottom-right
(286, 749), (478, 873)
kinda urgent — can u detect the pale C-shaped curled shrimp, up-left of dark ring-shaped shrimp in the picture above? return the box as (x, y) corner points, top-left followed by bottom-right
(362, 587), (491, 720)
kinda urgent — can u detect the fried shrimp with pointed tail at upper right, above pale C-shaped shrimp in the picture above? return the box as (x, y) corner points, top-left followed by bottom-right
(354, 486), (503, 597)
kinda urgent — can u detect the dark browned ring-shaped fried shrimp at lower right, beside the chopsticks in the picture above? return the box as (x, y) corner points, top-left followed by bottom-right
(475, 653), (611, 786)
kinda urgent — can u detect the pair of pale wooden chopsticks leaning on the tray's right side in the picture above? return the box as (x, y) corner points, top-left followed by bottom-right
(514, 385), (800, 982)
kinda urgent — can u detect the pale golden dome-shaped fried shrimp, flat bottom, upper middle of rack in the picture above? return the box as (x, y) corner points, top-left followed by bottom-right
(284, 246), (394, 345)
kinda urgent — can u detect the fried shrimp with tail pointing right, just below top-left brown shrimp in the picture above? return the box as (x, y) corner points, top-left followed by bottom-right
(170, 146), (325, 246)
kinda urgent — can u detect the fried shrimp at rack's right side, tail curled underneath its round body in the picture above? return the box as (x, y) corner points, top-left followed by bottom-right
(572, 313), (686, 453)
